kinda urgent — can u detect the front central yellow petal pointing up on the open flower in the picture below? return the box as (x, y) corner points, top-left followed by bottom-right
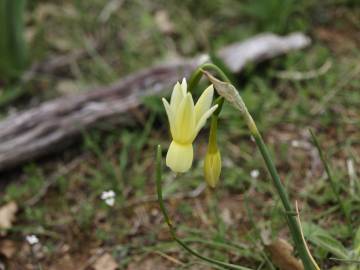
(173, 93), (195, 144)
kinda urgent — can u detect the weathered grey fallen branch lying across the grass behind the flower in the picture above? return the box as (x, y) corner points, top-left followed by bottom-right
(0, 33), (310, 170)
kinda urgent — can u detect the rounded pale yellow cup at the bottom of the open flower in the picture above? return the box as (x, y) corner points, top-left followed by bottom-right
(166, 141), (194, 173)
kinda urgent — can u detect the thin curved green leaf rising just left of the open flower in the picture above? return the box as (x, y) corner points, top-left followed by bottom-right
(156, 145), (251, 270)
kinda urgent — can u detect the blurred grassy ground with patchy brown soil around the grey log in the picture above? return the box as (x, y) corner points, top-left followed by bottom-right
(0, 0), (360, 270)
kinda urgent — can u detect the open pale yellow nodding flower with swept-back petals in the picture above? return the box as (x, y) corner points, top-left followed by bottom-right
(162, 78), (217, 173)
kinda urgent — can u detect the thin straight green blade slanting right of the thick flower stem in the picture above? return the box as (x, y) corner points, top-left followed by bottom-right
(309, 129), (353, 235)
